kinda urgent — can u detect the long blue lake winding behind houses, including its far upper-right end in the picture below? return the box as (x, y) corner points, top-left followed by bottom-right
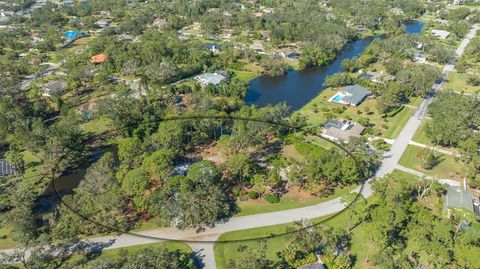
(245, 21), (425, 111)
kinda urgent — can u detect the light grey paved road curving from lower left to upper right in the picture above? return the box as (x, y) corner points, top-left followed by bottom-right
(5, 26), (478, 269)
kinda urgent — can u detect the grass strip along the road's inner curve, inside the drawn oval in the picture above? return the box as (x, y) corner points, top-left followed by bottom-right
(235, 185), (357, 216)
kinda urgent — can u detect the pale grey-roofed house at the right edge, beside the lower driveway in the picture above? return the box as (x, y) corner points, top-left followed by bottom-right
(444, 186), (480, 215)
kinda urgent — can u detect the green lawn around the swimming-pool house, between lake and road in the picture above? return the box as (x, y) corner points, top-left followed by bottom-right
(295, 88), (414, 138)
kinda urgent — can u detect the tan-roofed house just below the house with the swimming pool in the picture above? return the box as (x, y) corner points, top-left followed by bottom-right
(322, 119), (365, 142)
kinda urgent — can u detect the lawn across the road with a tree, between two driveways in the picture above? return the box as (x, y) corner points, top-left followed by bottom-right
(400, 145), (463, 180)
